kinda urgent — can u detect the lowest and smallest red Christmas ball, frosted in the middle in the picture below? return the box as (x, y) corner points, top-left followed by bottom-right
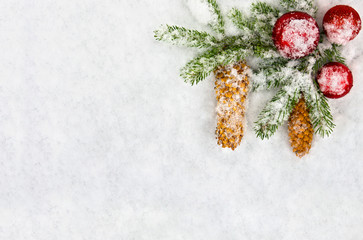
(316, 62), (353, 98)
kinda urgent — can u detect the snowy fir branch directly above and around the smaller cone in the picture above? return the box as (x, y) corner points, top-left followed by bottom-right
(252, 54), (335, 139)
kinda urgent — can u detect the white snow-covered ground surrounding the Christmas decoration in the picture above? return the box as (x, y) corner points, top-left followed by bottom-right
(0, 0), (363, 240)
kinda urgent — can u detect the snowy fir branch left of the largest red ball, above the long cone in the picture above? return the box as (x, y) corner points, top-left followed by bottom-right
(154, 0), (279, 85)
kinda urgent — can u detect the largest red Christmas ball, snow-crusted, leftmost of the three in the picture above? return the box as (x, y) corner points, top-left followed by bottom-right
(272, 12), (320, 59)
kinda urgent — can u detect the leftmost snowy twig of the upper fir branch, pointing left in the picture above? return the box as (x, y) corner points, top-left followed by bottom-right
(154, 25), (219, 48)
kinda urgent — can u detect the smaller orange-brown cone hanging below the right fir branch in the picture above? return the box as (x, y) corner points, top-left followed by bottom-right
(289, 97), (314, 158)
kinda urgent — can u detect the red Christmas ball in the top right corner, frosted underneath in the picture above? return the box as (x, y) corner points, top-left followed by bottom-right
(323, 5), (362, 45)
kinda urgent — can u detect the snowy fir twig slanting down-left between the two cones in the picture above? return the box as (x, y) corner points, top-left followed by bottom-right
(254, 86), (301, 139)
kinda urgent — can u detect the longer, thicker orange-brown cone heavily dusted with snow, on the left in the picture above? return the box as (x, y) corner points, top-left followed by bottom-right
(214, 62), (250, 150)
